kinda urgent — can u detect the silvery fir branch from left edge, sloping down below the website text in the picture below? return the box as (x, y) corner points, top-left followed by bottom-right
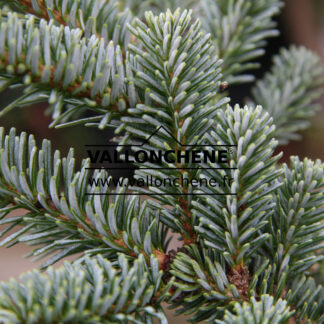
(0, 128), (167, 267)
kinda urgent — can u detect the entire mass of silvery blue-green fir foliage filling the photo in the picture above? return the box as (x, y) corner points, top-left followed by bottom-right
(0, 0), (324, 324)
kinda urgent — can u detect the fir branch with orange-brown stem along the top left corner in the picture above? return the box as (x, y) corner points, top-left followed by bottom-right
(2, 0), (132, 49)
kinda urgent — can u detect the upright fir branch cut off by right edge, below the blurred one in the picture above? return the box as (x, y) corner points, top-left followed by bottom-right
(266, 157), (324, 282)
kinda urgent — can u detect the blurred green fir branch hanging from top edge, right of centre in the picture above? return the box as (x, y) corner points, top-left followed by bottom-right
(200, 0), (282, 84)
